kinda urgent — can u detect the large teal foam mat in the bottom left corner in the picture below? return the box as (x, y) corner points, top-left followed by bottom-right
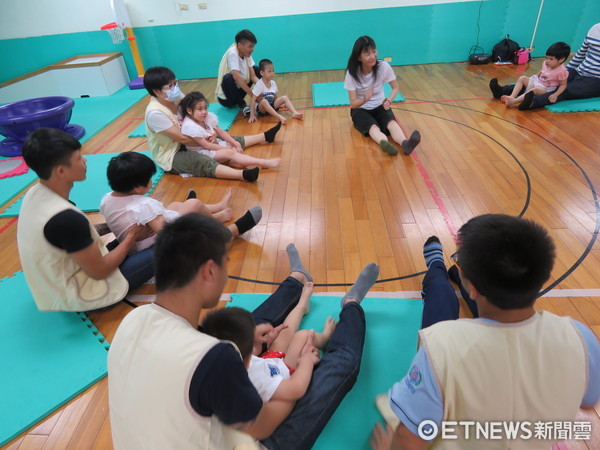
(0, 272), (108, 445)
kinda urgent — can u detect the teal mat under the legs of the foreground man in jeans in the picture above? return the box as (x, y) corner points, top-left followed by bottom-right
(230, 294), (423, 450)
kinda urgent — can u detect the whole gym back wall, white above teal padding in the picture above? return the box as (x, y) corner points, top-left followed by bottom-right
(0, 0), (600, 82)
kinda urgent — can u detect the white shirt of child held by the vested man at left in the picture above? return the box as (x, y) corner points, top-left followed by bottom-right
(100, 192), (180, 252)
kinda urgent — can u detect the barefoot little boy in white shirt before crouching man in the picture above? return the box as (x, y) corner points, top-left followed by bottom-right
(244, 59), (304, 125)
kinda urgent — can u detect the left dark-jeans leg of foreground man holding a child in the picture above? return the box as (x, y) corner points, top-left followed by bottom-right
(252, 277), (304, 327)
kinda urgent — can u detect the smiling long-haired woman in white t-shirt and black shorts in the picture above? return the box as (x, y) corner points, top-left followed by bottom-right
(344, 36), (421, 155)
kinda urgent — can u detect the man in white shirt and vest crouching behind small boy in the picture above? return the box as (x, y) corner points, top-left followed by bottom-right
(215, 30), (260, 115)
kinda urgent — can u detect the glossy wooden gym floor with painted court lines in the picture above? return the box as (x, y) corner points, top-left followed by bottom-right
(0, 60), (600, 449)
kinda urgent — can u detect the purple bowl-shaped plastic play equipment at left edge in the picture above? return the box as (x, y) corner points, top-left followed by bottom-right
(0, 97), (85, 157)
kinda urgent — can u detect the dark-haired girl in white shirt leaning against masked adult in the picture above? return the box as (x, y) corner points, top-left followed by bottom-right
(179, 92), (281, 171)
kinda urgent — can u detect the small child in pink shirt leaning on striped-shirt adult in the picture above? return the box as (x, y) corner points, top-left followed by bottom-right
(500, 42), (571, 108)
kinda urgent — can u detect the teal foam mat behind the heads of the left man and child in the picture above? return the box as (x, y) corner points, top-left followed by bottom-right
(0, 150), (164, 217)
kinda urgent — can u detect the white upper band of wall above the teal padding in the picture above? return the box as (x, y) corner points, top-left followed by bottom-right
(0, 0), (478, 39)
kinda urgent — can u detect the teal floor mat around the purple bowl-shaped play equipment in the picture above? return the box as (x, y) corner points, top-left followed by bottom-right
(0, 87), (147, 212)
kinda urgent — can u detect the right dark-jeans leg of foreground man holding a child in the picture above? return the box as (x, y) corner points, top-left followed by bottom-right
(262, 302), (365, 450)
